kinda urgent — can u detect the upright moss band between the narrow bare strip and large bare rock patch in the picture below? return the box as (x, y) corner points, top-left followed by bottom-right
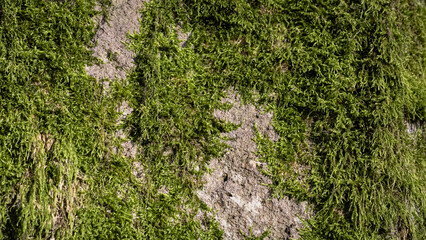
(126, 1), (240, 239)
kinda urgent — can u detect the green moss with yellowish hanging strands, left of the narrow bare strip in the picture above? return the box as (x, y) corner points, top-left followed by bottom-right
(0, 0), (131, 239)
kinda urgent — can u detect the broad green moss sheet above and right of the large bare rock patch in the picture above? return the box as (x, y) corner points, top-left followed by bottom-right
(131, 0), (426, 239)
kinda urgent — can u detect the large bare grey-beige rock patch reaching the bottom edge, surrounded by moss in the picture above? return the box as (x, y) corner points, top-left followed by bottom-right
(197, 90), (308, 239)
